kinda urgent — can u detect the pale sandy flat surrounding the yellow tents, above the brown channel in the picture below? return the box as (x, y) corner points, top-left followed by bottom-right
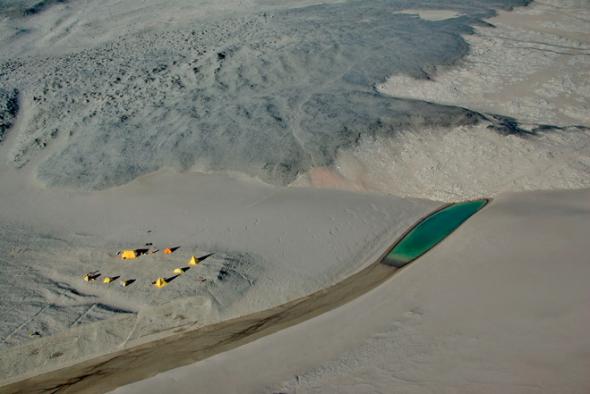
(0, 164), (439, 379)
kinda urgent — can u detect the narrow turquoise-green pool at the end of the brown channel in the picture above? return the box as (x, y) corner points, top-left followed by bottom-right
(383, 200), (488, 268)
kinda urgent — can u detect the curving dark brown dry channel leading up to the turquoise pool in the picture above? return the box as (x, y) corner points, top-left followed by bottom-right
(1, 248), (399, 393)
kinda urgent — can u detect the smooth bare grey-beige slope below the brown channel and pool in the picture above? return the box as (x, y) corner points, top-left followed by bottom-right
(115, 190), (590, 394)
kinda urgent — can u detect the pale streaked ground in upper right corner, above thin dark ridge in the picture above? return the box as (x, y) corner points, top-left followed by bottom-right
(378, 0), (590, 126)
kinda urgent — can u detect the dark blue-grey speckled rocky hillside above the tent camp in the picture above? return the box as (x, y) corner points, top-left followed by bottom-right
(0, 0), (523, 189)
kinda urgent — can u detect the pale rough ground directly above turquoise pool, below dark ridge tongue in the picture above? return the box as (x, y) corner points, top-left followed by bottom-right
(298, 123), (590, 201)
